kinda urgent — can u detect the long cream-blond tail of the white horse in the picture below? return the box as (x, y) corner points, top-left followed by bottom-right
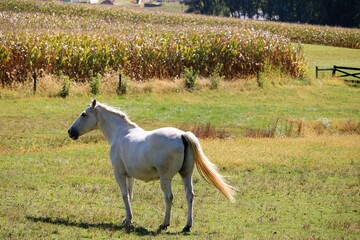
(183, 132), (236, 202)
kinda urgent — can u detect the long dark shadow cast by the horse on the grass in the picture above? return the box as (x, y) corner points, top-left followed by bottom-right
(26, 216), (159, 236)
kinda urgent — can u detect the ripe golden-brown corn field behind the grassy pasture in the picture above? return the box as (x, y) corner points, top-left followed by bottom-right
(0, 0), (360, 85)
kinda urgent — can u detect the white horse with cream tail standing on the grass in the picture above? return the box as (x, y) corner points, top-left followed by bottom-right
(68, 100), (235, 232)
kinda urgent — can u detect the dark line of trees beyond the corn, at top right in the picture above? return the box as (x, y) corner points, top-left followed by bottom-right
(182, 0), (360, 28)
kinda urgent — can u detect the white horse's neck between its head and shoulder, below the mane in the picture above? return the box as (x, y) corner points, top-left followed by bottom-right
(97, 108), (133, 144)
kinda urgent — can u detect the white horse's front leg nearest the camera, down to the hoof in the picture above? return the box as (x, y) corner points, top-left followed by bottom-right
(114, 168), (132, 227)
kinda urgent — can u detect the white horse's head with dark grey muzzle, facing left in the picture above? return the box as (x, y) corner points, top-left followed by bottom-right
(68, 99), (97, 140)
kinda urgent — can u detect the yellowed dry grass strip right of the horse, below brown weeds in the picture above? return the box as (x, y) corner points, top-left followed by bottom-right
(201, 135), (360, 169)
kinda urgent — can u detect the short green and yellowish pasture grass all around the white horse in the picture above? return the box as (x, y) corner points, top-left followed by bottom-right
(0, 80), (360, 239)
